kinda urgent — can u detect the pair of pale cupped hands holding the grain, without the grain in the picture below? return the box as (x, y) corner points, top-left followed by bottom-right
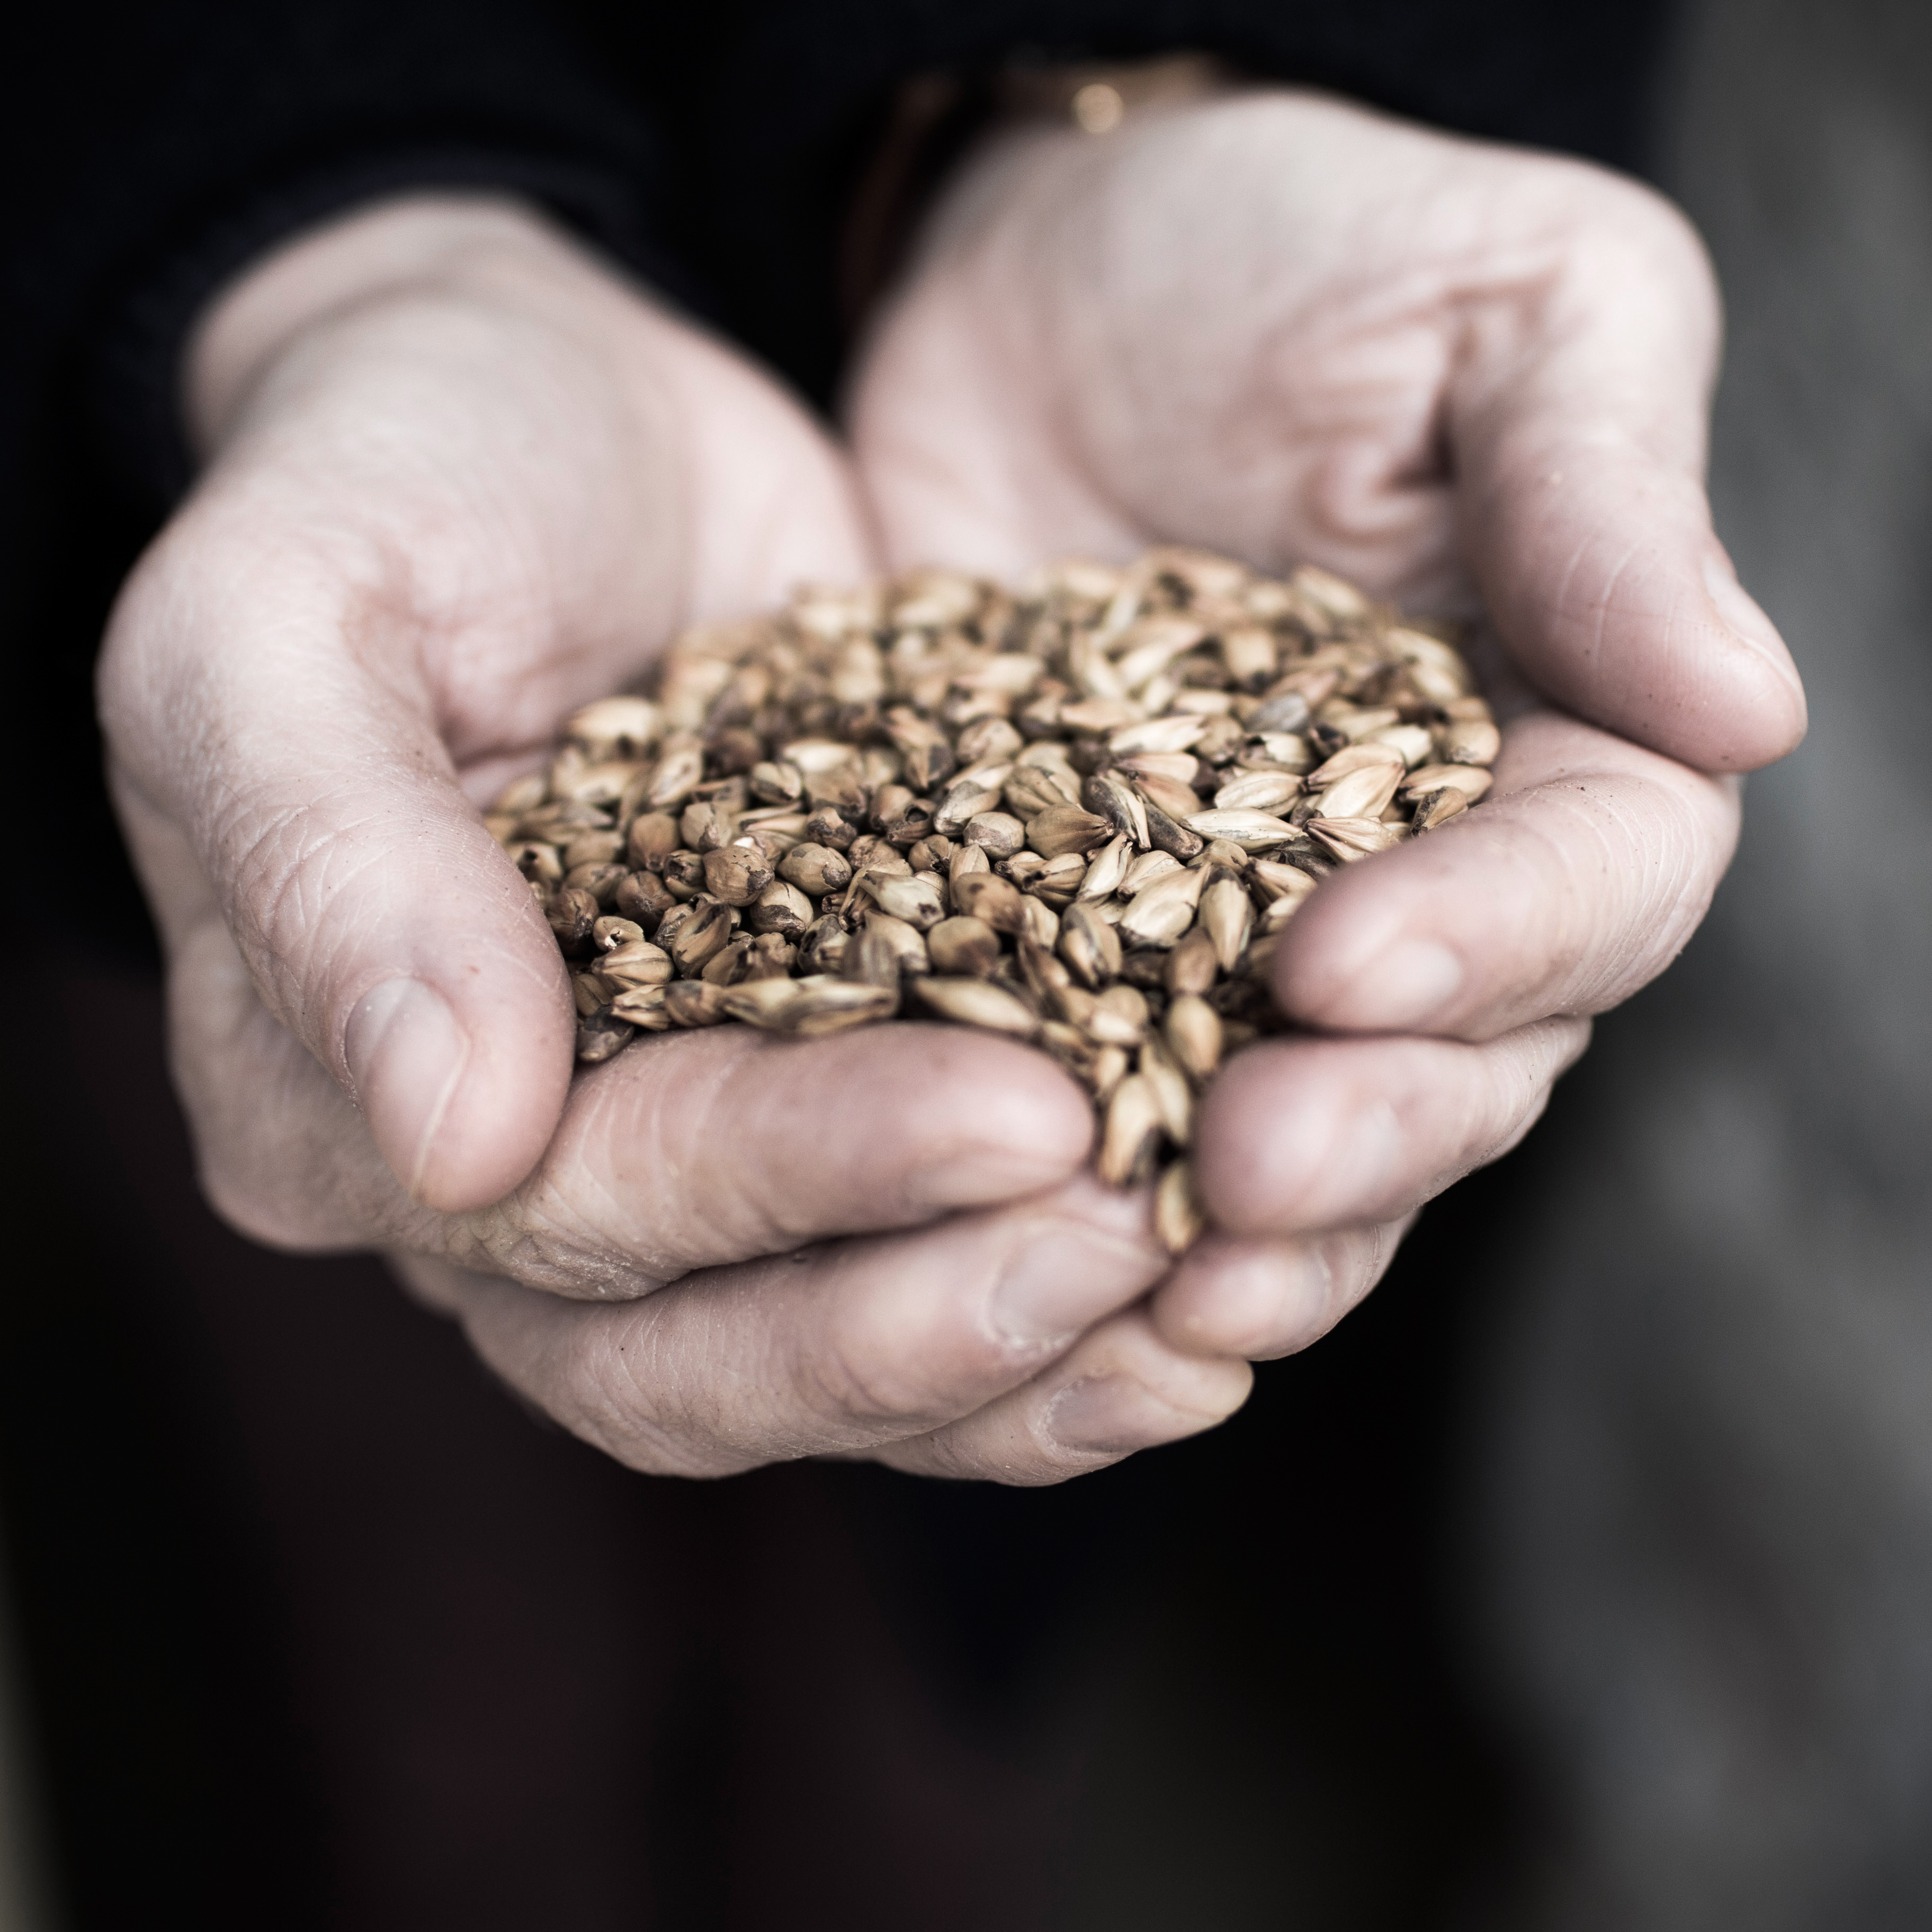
(101, 91), (1803, 1482)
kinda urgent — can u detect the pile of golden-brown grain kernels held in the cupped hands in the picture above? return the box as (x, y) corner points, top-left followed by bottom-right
(487, 549), (1497, 1252)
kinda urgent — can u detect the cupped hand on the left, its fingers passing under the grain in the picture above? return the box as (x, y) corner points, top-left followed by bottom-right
(101, 197), (1248, 1482)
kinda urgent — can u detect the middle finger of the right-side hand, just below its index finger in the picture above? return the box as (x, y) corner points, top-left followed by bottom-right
(1194, 1020), (1590, 1237)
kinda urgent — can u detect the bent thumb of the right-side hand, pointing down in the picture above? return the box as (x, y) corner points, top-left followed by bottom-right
(1445, 164), (1804, 771)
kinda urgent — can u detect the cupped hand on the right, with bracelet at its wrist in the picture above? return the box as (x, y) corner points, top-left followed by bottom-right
(850, 91), (1804, 1358)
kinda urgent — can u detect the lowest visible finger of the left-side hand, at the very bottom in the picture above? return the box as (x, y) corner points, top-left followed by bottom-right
(875, 1308), (1254, 1486)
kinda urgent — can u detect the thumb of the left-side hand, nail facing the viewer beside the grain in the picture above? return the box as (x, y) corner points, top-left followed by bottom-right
(101, 508), (574, 1213)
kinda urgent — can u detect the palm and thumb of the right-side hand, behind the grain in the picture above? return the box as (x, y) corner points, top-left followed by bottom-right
(852, 95), (1801, 784)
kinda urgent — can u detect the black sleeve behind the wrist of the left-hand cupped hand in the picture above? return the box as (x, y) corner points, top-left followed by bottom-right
(0, 0), (719, 500)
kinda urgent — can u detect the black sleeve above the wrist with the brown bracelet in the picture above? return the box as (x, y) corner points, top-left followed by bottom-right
(661, 0), (1671, 400)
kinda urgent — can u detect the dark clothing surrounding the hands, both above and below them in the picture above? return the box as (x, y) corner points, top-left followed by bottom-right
(0, 0), (1663, 1932)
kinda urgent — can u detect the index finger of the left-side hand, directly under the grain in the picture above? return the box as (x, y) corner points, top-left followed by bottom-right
(156, 881), (1092, 1298)
